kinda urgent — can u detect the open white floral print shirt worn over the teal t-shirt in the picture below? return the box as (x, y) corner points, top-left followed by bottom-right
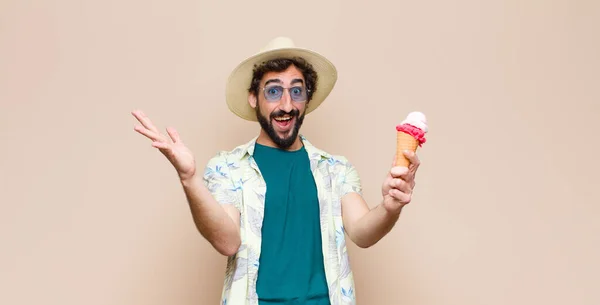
(204, 135), (362, 305)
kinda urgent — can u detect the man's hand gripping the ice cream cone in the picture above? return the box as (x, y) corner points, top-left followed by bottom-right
(381, 151), (420, 213)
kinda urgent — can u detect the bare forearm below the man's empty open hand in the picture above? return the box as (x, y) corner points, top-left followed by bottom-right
(180, 172), (241, 256)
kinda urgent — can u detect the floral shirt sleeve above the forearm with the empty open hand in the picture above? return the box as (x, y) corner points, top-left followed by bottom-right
(203, 153), (242, 210)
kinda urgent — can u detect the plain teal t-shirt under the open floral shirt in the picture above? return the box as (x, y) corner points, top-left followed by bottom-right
(254, 143), (330, 305)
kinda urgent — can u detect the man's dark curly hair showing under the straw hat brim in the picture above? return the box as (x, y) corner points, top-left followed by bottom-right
(248, 57), (318, 101)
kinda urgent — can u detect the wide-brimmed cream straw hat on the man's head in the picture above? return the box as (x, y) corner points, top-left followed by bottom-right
(225, 37), (337, 121)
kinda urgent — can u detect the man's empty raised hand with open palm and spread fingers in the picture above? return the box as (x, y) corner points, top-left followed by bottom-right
(131, 110), (196, 179)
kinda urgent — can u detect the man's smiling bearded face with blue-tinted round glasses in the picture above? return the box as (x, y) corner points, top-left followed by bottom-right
(248, 65), (308, 150)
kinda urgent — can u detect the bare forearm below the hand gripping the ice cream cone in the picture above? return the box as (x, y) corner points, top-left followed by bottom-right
(352, 204), (401, 248)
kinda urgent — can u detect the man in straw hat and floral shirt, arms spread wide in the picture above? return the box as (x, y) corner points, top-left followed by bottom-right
(133, 38), (419, 305)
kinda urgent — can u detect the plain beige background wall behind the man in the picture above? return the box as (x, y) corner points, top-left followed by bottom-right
(0, 0), (600, 305)
